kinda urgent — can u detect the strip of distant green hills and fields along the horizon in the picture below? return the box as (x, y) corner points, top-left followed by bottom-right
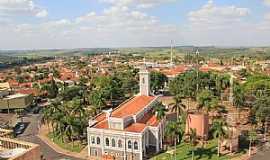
(0, 46), (270, 58)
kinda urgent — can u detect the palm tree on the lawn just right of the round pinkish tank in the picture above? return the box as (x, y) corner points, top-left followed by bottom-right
(212, 119), (228, 157)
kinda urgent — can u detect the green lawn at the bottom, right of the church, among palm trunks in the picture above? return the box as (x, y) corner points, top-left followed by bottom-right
(151, 140), (244, 160)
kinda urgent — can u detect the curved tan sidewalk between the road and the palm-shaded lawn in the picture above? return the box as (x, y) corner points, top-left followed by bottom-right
(37, 125), (89, 160)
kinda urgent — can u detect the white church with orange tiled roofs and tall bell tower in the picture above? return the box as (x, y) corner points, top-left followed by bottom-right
(87, 68), (164, 160)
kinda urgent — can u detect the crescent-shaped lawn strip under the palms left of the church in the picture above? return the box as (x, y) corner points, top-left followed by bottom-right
(48, 133), (85, 153)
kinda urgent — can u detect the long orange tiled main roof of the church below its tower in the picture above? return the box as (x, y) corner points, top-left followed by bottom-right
(112, 96), (155, 118)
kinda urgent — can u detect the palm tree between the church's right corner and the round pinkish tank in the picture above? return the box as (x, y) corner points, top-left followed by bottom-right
(165, 121), (184, 160)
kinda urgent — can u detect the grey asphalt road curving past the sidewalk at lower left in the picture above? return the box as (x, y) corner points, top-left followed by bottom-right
(17, 114), (81, 160)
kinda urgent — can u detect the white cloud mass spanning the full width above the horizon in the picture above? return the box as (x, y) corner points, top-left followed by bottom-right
(0, 0), (270, 49)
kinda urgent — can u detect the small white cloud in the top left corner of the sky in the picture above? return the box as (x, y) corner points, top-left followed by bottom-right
(0, 0), (48, 18)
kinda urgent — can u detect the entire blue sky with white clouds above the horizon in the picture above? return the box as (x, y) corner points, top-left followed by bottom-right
(0, 0), (270, 49)
